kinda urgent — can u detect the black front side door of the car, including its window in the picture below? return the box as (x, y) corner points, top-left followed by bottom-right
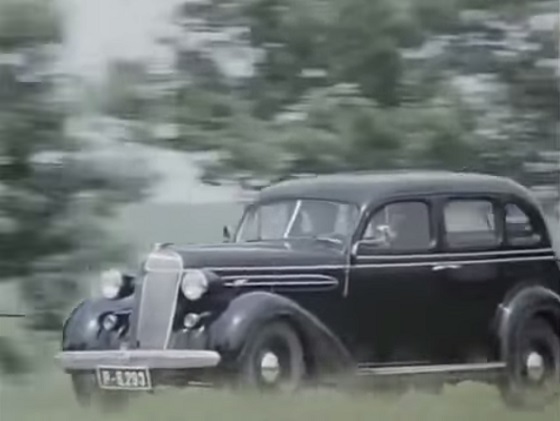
(347, 198), (439, 363)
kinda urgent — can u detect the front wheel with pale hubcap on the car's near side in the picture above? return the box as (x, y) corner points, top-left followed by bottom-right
(237, 322), (306, 393)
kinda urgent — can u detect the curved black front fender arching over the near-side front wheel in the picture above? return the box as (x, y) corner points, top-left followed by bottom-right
(208, 292), (353, 372)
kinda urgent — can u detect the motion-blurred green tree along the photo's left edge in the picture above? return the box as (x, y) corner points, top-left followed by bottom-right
(0, 0), (151, 348)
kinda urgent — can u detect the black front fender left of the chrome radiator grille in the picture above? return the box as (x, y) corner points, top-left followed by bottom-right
(62, 297), (132, 351)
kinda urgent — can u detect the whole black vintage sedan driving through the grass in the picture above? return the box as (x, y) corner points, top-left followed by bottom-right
(57, 172), (560, 406)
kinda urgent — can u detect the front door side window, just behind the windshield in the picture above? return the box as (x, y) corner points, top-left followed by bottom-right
(363, 201), (432, 252)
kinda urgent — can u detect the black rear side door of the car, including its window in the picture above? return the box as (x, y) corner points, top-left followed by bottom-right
(433, 195), (507, 359)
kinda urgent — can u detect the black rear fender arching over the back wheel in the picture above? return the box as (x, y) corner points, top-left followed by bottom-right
(495, 285), (560, 361)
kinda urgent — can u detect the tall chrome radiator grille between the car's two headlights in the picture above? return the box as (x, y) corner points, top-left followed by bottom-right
(132, 249), (183, 349)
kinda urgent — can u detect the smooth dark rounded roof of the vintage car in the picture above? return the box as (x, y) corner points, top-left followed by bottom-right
(257, 171), (536, 206)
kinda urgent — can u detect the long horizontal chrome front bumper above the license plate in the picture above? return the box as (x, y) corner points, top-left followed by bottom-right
(56, 349), (221, 371)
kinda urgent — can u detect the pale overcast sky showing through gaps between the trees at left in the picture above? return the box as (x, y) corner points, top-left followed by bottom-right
(59, 0), (241, 203)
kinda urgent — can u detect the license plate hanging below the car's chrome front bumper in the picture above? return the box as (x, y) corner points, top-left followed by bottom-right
(97, 367), (152, 390)
